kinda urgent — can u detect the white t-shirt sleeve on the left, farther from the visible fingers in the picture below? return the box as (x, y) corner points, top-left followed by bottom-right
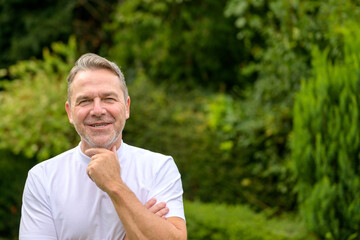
(19, 171), (57, 240)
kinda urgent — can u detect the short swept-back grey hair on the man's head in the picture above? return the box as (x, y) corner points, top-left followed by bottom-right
(67, 53), (129, 104)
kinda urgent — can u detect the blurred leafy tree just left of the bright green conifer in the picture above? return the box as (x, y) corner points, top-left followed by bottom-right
(221, 0), (360, 209)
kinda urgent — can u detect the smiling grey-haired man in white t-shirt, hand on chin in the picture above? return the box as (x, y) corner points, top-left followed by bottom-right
(19, 54), (187, 240)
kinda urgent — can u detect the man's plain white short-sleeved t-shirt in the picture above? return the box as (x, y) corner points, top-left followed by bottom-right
(19, 142), (185, 240)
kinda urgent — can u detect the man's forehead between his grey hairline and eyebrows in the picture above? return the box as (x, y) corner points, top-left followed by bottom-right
(70, 69), (123, 97)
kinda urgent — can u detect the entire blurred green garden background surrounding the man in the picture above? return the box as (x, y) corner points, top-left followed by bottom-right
(0, 0), (360, 240)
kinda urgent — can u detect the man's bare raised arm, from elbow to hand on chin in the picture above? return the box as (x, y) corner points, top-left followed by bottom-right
(86, 147), (187, 239)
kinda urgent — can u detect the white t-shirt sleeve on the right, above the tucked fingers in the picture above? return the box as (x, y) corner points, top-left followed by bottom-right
(149, 157), (185, 220)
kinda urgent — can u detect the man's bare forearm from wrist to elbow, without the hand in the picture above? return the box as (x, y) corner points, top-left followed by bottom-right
(107, 183), (186, 240)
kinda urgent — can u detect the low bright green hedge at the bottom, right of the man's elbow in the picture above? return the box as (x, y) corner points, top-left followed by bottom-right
(185, 201), (315, 240)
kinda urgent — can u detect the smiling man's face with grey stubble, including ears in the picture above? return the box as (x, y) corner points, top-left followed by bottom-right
(65, 69), (130, 151)
